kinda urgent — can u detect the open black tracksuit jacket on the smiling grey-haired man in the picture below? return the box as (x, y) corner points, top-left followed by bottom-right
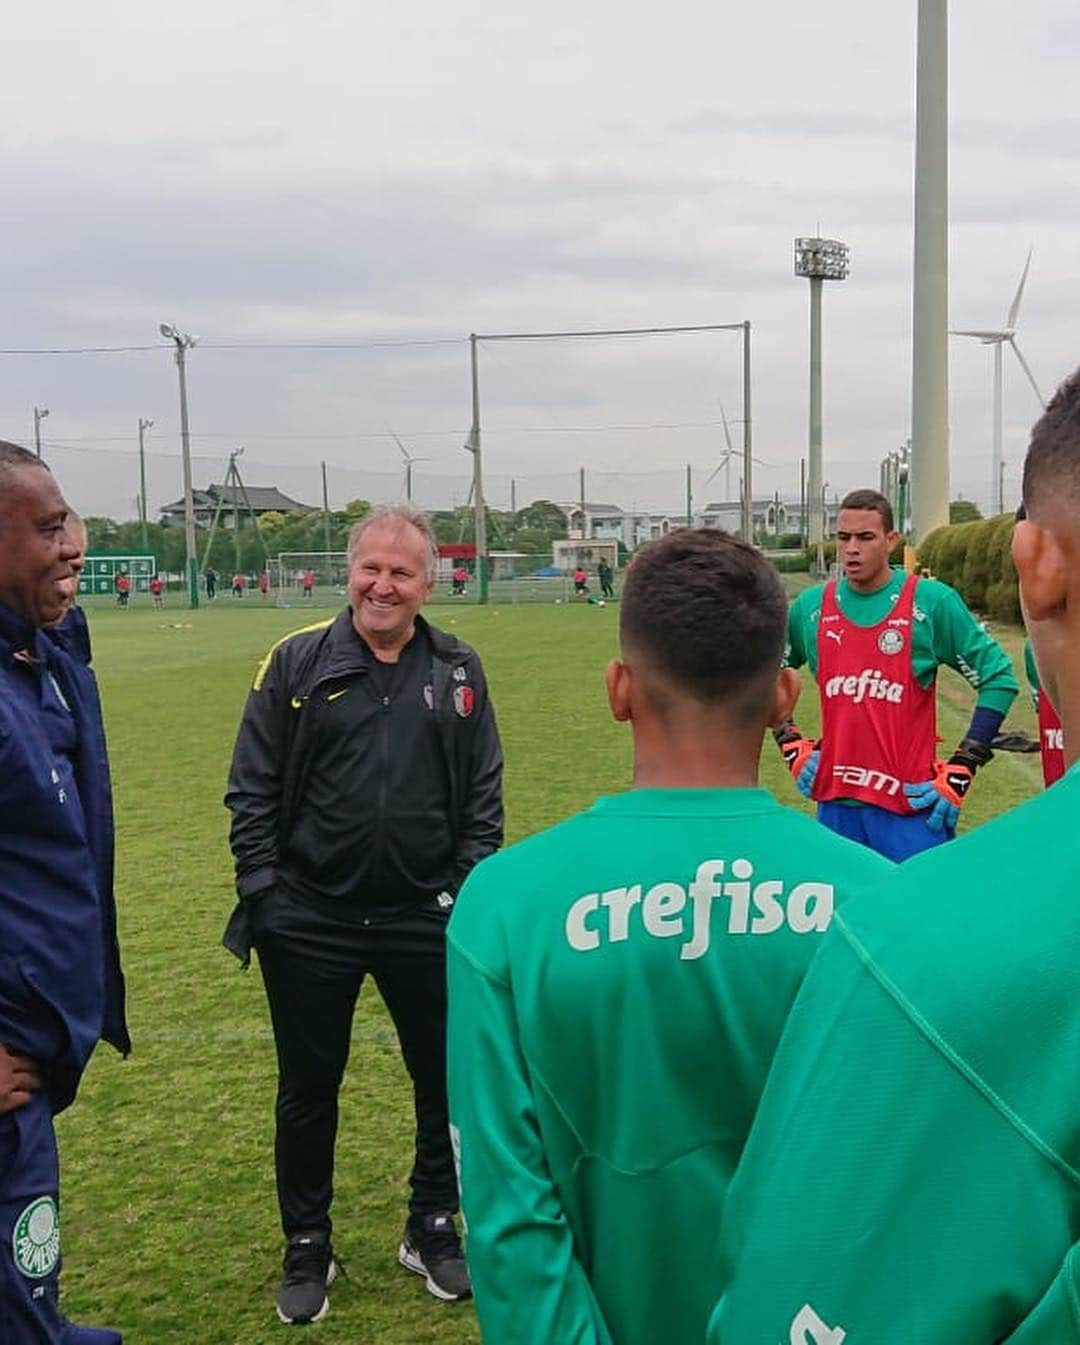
(223, 608), (503, 962)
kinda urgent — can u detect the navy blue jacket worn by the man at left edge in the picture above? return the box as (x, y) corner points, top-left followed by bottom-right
(0, 603), (130, 1111)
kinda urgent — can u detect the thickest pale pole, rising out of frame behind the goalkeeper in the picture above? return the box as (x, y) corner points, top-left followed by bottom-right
(909, 0), (950, 542)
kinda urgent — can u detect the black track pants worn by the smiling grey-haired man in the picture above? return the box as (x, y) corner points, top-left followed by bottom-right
(253, 893), (457, 1237)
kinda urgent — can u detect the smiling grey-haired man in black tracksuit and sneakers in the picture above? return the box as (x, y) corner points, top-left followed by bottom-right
(225, 508), (503, 1322)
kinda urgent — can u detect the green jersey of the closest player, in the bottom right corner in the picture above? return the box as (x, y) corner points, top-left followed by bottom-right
(709, 767), (1080, 1345)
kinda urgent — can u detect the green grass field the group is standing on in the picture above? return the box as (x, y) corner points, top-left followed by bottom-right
(59, 600), (1041, 1345)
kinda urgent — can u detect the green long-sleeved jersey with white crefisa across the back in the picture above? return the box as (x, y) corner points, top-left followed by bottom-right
(448, 790), (893, 1345)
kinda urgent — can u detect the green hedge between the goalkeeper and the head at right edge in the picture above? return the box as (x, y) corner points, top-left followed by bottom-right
(919, 514), (1019, 623)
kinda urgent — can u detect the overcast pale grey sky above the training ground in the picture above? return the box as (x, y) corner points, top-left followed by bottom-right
(0, 0), (1080, 518)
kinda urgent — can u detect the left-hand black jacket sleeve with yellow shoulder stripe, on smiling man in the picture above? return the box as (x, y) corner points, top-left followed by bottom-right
(222, 651), (291, 963)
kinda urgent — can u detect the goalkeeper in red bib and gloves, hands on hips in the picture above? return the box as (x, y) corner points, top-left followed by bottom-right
(775, 490), (1019, 862)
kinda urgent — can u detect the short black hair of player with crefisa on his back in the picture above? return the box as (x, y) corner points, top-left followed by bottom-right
(619, 527), (788, 721)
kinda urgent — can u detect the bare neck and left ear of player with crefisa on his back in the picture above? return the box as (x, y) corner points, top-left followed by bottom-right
(608, 650), (765, 790)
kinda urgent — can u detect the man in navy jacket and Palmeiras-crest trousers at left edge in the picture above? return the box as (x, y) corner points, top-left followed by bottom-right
(0, 441), (130, 1345)
